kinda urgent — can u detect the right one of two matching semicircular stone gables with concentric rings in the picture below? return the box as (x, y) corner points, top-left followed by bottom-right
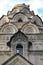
(21, 23), (39, 34)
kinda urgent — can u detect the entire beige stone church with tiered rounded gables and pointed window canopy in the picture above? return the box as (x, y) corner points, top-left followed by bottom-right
(0, 3), (43, 65)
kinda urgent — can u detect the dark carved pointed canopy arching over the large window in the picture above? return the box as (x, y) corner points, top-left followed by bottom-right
(7, 30), (28, 47)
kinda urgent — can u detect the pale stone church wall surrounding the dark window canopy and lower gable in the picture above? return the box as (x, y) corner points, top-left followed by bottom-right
(0, 4), (43, 65)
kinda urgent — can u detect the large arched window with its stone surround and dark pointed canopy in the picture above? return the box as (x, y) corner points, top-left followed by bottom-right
(7, 30), (28, 56)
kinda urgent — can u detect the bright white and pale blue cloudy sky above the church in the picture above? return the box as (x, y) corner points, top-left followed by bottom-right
(0, 0), (43, 20)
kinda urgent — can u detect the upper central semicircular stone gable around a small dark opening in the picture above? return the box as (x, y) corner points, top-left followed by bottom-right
(10, 12), (29, 22)
